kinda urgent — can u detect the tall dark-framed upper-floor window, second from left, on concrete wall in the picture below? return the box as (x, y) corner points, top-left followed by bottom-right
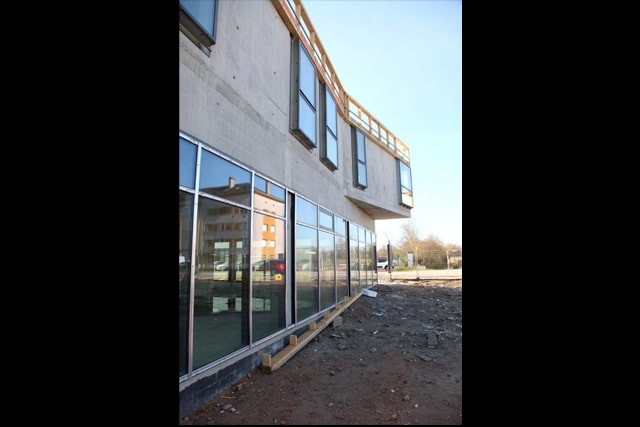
(290, 39), (317, 148)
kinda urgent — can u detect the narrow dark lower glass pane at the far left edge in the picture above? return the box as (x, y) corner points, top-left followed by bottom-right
(178, 191), (194, 376)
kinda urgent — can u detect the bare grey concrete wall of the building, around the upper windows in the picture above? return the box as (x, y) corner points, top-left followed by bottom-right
(178, 0), (411, 420)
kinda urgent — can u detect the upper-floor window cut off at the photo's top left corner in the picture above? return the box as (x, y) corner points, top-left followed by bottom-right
(179, 0), (218, 52)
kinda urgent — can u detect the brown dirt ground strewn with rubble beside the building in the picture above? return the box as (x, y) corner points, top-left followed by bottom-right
(180, 279), (462, 425)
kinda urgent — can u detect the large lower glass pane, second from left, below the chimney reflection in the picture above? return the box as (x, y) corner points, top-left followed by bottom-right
(193, 196), (250, 369)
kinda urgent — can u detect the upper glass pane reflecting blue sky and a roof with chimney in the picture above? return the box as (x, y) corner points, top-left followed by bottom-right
(200, 150), (251, 206)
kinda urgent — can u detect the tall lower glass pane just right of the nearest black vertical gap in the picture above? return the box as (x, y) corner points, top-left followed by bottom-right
(295, 225), (319, 322)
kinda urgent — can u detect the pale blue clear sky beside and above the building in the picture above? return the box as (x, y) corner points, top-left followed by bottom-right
(302, 0), (462, 247)
